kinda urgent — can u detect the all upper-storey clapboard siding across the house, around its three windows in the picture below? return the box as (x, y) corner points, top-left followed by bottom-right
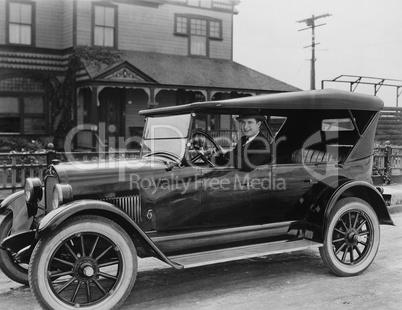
(0, 0), (232, 59)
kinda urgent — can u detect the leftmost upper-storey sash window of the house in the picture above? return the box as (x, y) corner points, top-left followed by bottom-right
(8, 1), (34, 45)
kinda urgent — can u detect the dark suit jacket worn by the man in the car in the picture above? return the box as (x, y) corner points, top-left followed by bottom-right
(225, 132), (271, 172)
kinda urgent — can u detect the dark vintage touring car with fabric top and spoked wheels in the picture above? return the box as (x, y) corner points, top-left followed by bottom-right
(0, 90), (393, 310)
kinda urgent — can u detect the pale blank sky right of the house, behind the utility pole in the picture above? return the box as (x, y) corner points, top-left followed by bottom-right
(233, 0), (402, 107)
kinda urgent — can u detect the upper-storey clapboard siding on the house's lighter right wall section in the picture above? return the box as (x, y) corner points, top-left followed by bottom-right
(77, 1), (232, 59)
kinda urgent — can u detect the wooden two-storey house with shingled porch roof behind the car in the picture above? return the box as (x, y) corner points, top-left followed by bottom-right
(0, 0), (298, 149)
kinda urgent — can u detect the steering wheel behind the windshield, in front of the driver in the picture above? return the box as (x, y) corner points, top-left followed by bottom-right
(186, 131), (219, 167)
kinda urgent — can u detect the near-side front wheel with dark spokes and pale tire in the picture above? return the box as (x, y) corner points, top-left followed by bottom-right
(29, 215), (137, 310)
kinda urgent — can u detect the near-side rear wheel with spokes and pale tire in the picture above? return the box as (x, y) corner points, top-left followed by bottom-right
(320, 198), (380, 277)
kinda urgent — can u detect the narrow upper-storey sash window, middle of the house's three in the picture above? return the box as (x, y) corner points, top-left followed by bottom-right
(93, 4), (117, 47)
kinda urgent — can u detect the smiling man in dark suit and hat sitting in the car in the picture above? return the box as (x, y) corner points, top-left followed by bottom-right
(225, 114), (271, 172)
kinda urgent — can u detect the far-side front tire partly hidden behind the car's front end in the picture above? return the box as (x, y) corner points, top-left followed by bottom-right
(0, 211), (28, 285)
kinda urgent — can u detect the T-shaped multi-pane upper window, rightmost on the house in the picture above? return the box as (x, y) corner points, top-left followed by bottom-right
(175, 15), (222, 56)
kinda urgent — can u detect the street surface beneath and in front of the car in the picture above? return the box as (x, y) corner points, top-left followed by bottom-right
(0, 213), (402, 310)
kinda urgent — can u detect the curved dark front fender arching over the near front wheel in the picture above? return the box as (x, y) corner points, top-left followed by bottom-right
(36, 200), (182, 269)
